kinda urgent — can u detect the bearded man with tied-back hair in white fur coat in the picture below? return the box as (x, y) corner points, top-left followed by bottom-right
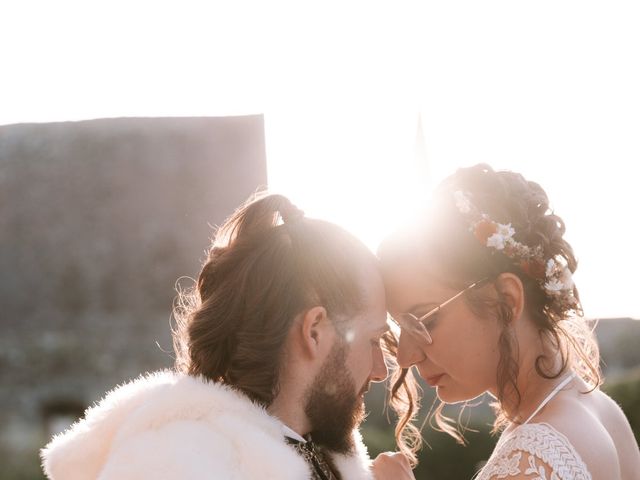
(42, 195), (402, 480)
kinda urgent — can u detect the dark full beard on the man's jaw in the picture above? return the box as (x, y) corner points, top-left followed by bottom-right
(305, 342), (368, 453)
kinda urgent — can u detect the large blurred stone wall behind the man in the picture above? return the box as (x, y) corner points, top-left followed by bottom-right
(0, 116), (267, 479)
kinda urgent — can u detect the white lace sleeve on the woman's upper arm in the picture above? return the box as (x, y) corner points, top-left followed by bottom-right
(476, 423), (591, 480)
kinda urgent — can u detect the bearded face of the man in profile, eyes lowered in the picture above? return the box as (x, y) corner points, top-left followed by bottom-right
(305, 274), (388, 453)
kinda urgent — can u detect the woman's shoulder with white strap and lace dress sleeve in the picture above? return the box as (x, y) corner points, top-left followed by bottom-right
(479, 390), (638, 480)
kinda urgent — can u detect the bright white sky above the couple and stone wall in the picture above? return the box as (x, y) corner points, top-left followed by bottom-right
(0, 0), (640, 318)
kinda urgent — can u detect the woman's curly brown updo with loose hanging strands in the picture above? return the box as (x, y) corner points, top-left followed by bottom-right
(380, 164), (601, 452)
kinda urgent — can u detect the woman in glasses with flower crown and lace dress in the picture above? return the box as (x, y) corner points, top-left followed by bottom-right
(379, 165), (640, 480)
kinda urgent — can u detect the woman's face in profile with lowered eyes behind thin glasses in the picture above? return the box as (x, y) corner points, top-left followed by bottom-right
(383, 261), (500, 403)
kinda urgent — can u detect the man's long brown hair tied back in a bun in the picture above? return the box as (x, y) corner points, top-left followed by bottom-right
(173, 195), (377, 406)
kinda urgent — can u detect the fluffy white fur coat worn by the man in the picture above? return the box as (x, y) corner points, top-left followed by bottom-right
(41, 371), (373, 480)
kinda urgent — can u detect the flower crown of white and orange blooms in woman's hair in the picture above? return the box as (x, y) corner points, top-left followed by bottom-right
(453, 190), (578, 308)
